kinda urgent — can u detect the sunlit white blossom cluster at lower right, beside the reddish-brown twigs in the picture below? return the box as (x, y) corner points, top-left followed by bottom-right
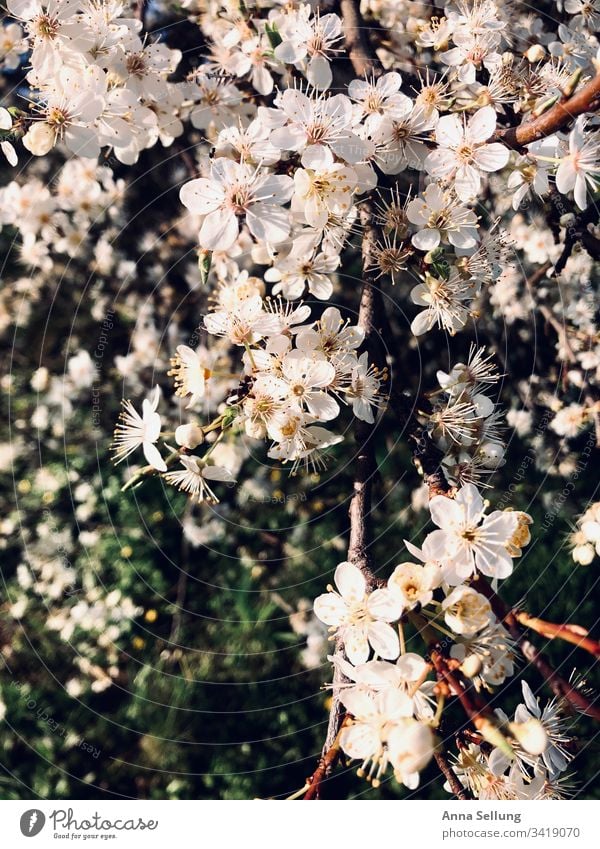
(314, 484), (540, 788)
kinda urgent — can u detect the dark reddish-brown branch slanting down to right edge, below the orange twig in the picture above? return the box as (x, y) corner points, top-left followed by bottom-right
(472, 575), (600, 720)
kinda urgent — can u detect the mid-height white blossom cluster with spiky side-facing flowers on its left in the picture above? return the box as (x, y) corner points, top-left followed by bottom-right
(114, 296), (384, 502)
